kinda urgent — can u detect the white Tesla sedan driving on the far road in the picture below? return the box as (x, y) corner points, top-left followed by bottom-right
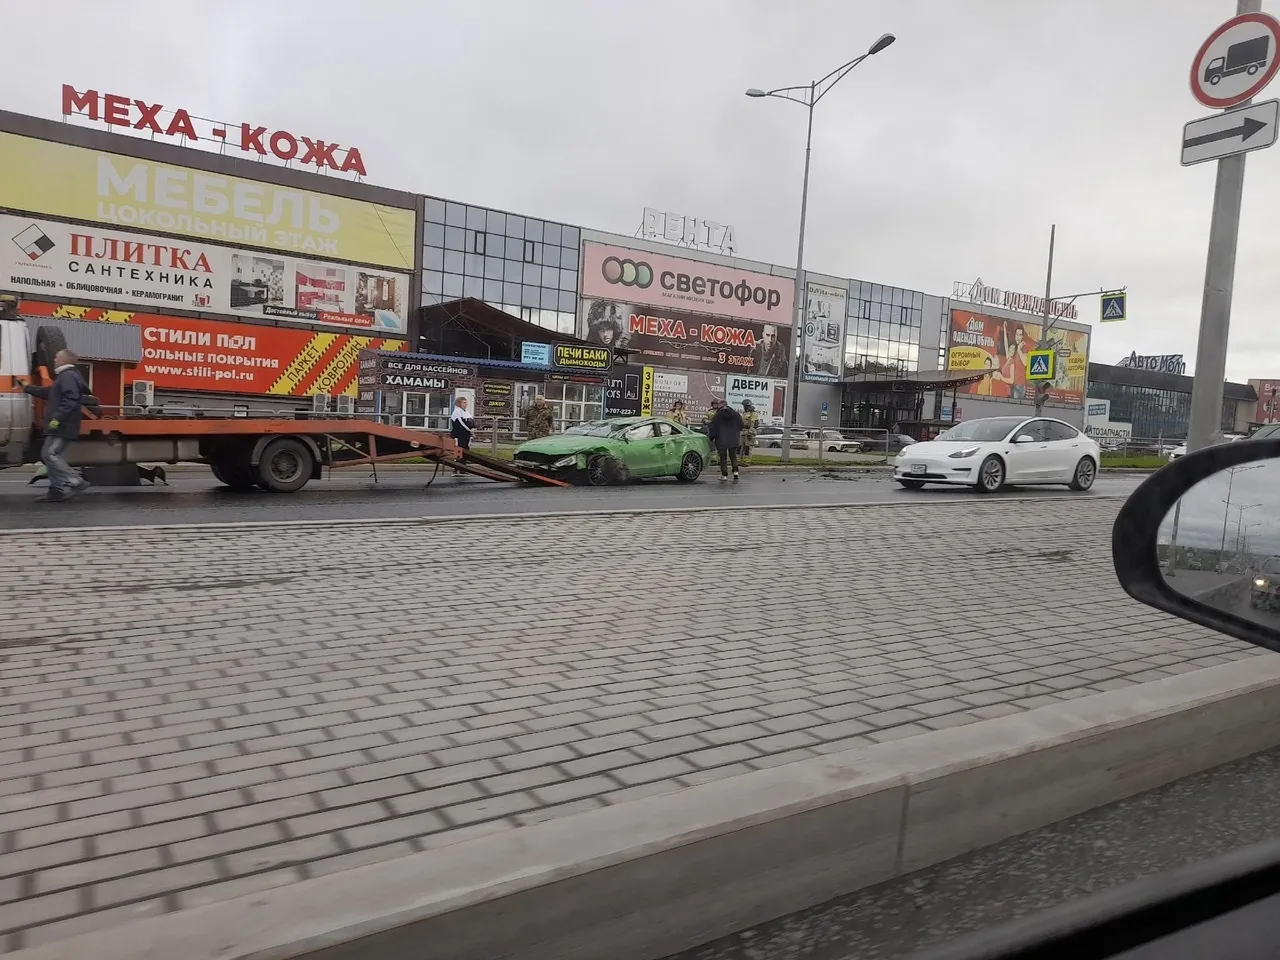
(893, 417), (1102, 493)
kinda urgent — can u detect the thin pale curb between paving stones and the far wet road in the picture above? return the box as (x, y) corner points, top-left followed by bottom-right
(0, 494), (1128, 538)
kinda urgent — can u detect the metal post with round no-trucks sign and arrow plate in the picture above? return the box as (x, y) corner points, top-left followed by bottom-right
(1183, 0), (1280, 452)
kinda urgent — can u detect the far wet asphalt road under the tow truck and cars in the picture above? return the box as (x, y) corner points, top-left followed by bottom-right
(0, 468), (1143, 530)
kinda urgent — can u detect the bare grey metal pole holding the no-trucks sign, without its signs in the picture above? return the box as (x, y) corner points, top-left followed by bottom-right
(1187, 0), (1262, 453)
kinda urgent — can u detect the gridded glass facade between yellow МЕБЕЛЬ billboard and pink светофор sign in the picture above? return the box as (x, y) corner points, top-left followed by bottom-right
(422, 197), (581, 334)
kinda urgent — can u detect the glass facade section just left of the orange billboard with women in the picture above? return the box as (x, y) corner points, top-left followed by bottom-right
(845, 280), (924, 379)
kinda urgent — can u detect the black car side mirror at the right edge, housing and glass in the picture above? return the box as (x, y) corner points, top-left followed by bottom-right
(1111, 440), (1280, 652)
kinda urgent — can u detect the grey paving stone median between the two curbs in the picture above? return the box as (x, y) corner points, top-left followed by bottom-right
(0, 497), (1253, 952)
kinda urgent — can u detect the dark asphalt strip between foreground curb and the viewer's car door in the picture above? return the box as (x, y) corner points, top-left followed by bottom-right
(668, 750), (1280, 960)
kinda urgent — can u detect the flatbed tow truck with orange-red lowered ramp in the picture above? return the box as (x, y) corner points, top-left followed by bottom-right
(0, 314), (567, 493)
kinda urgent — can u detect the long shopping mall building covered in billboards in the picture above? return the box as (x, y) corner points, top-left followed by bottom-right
(0, 100), (1239, 436)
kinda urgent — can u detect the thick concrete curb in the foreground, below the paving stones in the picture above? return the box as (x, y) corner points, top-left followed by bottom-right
(13, 657), (1280, 960)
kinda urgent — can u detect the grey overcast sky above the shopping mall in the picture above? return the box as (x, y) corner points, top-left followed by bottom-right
(0, 0), (1280, 380)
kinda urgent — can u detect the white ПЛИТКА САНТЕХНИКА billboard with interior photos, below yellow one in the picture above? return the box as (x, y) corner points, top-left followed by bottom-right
(0, 215), (410, 335)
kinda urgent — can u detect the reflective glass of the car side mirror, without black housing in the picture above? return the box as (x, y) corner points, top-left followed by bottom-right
(1157, 460), (1280, 630)
